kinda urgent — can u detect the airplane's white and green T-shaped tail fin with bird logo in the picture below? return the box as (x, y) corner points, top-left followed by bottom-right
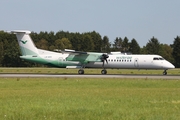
(11, 30), (38, 56)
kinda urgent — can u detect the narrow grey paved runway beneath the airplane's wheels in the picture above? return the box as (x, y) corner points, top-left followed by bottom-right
(0, 74), (180, 80)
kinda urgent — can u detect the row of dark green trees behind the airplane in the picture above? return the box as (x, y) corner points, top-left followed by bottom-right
(0, 31), (180, 67)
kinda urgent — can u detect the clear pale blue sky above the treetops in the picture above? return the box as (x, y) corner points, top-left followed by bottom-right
(0, 0), (180, 47)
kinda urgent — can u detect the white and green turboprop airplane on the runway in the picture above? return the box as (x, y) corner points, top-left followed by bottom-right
(11, 30), (175, 75)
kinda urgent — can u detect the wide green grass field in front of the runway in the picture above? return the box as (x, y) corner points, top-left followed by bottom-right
(0, 78), (180, 120)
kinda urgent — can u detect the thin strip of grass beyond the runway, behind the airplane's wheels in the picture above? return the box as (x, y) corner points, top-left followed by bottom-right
(0, 67), (180, 75)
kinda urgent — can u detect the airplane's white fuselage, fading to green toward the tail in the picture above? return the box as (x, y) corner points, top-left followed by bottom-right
(21, 50), (175, 69)
